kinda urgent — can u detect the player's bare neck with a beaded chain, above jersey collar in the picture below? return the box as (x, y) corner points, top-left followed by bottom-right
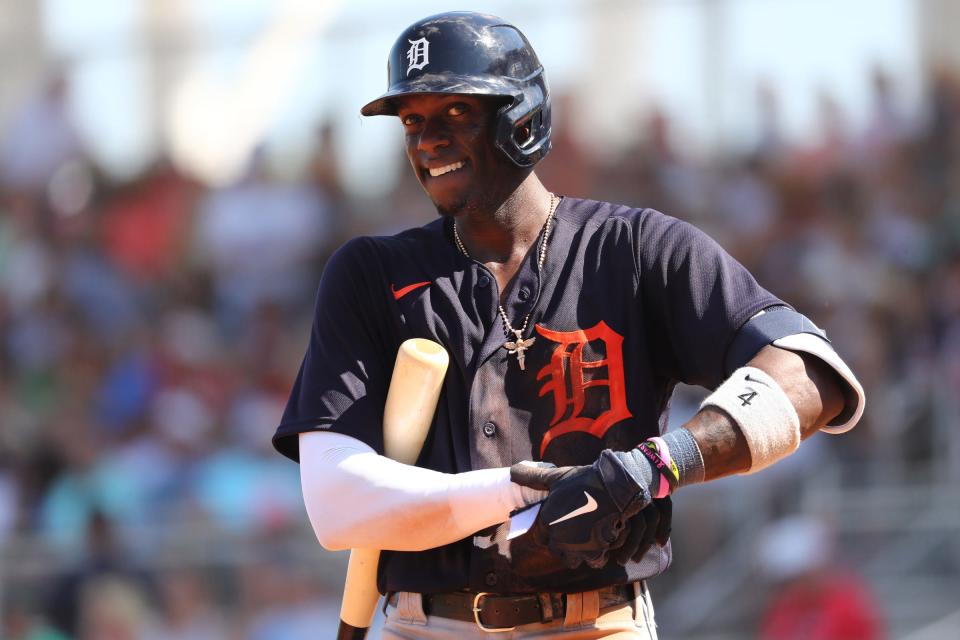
(455, 172), (551, 267)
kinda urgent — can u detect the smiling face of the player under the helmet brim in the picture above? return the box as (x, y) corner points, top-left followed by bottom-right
(395, 94), (529, 216)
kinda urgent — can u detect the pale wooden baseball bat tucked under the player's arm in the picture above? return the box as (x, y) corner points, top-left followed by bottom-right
(337, 338), (450, 640)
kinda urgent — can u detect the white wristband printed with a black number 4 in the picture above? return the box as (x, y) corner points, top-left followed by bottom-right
(700, 367), (800, 473)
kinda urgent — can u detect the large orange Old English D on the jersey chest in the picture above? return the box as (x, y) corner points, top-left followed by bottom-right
(536, 320), (632, 457)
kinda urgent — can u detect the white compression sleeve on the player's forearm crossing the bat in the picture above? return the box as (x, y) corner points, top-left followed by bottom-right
(300, 431), (524, 551)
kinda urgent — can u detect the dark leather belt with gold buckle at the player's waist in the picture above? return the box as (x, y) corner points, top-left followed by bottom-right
(387, 583), (635, 631)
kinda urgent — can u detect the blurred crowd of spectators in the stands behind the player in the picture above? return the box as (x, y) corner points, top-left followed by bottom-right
(0, 61), (960, 640)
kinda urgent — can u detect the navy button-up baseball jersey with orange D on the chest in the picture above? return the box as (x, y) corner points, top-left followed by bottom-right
(273, 198), (783, 593)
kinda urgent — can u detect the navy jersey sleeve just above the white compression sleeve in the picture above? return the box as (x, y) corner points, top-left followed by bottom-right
(273, 238), (396, 462)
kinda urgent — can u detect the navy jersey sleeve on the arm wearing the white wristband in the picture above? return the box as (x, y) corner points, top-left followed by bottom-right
(637, 210), (784, 389)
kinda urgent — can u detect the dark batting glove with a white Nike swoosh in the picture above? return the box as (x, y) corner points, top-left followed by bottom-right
(510, 449), (651, 569)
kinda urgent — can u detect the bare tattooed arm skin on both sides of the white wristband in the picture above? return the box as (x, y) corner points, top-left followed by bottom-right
(684, 345), (843, 481)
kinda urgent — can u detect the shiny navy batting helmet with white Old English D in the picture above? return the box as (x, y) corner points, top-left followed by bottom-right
(360, 11), (550, 167)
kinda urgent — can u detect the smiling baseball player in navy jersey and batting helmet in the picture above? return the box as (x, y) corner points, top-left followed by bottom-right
(274, 12), (864, 638)
